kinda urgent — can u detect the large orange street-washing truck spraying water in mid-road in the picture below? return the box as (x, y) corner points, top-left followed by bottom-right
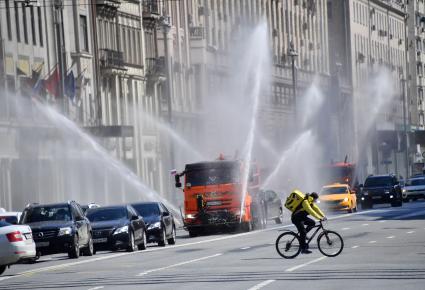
(175, 158), (260, 237)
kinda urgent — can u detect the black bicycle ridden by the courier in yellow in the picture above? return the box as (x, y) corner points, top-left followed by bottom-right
(276, 221), (344, 259)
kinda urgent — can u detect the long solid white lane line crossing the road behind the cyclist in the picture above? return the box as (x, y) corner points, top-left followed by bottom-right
(0, 210), (380, 281)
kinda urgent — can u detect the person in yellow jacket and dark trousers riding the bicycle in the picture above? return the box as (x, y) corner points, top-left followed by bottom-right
(291, 192), (326, 254)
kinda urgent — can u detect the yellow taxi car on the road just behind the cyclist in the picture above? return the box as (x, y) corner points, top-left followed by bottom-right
(319, 183), (357, 213)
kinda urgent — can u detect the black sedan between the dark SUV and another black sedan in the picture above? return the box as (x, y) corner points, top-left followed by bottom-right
(86, 205), (147, 252)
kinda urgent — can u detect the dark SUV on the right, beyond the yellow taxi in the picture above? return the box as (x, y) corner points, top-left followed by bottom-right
(360, 174), (403, 208)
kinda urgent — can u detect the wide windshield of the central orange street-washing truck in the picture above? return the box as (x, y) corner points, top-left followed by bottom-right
(186, 167), (239, 186)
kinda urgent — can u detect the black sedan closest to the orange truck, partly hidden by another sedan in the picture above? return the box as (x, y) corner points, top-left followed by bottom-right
(132, 202), (176, 247)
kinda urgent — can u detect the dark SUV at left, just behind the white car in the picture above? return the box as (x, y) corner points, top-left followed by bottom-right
(20, 201), (93, 258)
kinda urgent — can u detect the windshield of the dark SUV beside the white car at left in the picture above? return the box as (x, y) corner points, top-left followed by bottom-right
(22, 204), (72, 224)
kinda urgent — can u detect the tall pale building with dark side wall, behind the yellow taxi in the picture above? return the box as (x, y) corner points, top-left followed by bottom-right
(328, 0), (411, 180)
